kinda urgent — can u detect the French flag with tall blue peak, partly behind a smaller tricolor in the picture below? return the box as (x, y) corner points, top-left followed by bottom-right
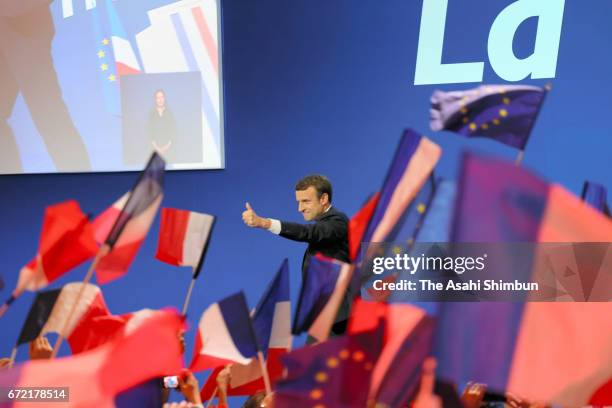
(201, 259), (292, 401)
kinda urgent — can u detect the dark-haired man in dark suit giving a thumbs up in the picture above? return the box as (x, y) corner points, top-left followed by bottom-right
(242, 175), (350, 334)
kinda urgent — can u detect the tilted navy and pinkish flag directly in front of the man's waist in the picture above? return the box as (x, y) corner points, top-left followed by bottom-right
(293, 256), (354, 342)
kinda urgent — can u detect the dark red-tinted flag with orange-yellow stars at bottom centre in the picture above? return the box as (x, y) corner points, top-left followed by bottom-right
(274, 320), (385, 408)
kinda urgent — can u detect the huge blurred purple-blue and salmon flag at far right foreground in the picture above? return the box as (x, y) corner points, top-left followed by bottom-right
(436, 155), (612, 405)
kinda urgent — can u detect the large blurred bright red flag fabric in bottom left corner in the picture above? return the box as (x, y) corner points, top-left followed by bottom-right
(0, 310), (184, 408)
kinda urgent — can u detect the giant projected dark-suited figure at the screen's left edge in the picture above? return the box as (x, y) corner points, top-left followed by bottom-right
(0, 0), (91, 173)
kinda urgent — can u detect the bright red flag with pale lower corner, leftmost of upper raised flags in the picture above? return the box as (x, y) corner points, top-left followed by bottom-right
(14, 200), (98, 295)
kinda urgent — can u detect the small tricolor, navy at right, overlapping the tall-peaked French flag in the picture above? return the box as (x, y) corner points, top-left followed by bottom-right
(190, 292), (258, 372)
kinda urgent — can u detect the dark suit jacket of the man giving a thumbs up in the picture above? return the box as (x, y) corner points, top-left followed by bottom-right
(280, 207), (352, 334)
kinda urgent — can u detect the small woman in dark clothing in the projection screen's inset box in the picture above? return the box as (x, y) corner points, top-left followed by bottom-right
(149, 89), (177, 162)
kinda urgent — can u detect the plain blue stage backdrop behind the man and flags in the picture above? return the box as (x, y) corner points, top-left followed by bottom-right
(0, 0), (612, 400)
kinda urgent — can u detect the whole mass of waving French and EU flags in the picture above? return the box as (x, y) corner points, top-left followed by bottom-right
(0, 81), (612, 407)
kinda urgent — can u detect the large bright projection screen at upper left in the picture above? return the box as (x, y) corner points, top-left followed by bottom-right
(0, 0), (225, 174)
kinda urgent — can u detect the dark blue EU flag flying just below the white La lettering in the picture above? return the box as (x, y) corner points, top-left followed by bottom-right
(430, 85), (548, 150)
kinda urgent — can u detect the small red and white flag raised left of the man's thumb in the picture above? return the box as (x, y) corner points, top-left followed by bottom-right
(156, 208), (215, 272)
